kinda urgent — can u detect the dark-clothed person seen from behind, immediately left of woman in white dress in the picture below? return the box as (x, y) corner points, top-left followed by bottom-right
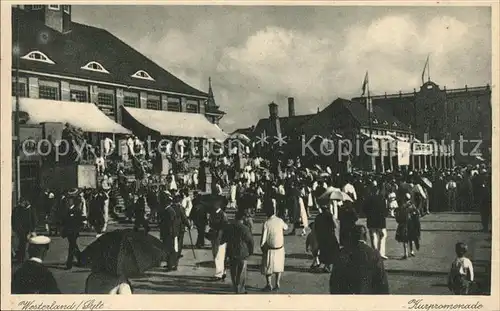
(221, 213), (254, 294)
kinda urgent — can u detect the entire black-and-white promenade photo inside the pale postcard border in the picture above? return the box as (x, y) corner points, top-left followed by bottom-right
(7, 3), (496, 298)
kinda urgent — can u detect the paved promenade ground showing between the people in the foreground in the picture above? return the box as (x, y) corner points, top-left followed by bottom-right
(13, 213), (491, 295)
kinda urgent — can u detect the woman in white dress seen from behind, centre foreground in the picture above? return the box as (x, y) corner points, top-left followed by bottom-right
(260, 205), (288, 291)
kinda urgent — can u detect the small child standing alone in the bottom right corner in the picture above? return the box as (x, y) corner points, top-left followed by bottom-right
(448, 242), (474, 295)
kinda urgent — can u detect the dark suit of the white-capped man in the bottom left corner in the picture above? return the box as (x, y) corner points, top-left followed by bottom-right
(11, 260), (61, 294)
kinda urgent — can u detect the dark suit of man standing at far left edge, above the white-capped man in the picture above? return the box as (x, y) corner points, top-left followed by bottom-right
(12, 206), (37, 262)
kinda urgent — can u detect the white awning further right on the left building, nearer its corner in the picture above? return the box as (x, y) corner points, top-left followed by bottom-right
(123, 107), (228, 141)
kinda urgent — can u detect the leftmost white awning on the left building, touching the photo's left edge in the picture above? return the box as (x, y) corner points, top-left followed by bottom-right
(12, 97), (130, 134)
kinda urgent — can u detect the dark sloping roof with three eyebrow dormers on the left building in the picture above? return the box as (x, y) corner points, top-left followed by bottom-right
(12, 8), (208, 98)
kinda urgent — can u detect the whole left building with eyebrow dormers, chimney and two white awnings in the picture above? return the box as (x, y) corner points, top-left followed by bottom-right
(12, 5), (225, 202)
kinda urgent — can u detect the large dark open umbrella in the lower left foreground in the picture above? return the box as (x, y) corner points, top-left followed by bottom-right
(81, 229), (167, 277)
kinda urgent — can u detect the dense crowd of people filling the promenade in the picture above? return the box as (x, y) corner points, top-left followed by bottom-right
(12, 138), (491, 294)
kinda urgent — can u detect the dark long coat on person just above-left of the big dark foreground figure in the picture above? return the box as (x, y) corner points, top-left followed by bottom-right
(314, 211), (340, 264)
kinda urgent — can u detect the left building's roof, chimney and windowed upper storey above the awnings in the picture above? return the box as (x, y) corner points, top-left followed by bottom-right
(12, 5), (224, 124)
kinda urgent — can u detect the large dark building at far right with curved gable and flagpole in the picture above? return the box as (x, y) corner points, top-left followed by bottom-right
(353, 81), (492, 161)
